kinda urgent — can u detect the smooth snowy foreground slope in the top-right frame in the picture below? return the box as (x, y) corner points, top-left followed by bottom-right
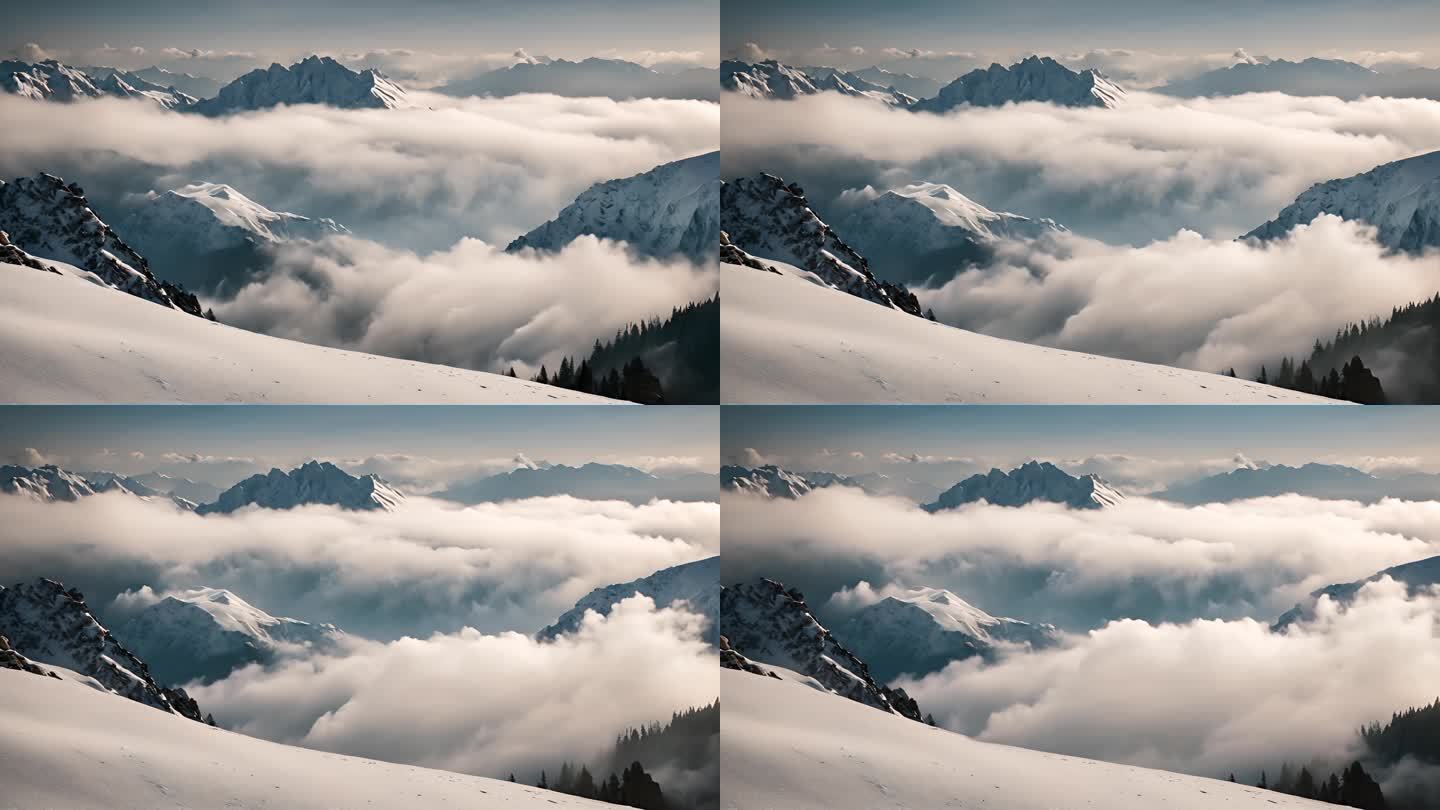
(720, 258), (1329, 404)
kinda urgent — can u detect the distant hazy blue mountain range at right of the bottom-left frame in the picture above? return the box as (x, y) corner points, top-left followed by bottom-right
(436, 461), (719, 503)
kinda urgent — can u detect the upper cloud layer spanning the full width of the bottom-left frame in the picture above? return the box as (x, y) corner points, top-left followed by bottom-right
(0, 494), (720, 638)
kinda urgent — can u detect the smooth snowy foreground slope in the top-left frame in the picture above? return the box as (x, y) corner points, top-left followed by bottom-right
(0, 262), (613, 404)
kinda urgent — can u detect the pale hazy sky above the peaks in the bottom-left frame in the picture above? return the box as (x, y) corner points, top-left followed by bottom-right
(0, 405), (719, 486)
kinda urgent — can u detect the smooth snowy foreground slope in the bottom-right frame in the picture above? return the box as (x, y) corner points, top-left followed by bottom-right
(720, 664), (1333, 810)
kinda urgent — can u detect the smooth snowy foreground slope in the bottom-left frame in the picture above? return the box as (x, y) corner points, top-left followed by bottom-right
(0, 669), (612, 810)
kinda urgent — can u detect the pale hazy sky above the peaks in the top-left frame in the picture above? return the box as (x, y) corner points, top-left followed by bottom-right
(0, 0), (719, 75)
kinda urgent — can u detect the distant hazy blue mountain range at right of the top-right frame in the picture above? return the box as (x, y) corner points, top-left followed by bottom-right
(1155, 58), (1385, 98)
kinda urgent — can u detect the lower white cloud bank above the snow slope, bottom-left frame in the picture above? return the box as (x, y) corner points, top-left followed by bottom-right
(192, 595), (720, 778)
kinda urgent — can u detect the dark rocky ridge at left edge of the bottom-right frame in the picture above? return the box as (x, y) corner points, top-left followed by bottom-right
(720, 579), (922, 721)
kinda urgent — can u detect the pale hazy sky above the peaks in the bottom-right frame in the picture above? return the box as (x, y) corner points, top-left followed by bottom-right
(721, 405), (1440, 471)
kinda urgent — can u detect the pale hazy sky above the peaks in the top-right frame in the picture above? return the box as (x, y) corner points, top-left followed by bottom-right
(721, 0), (1440, 67)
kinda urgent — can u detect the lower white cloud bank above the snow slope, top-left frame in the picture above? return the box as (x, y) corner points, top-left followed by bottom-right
(213, 236), (719, 376)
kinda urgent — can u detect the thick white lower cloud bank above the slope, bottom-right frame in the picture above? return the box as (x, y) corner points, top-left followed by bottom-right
(904, 579), (1440, 780)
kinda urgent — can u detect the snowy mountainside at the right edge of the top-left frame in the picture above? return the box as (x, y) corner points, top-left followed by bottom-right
(505, 151), (720, 262)
